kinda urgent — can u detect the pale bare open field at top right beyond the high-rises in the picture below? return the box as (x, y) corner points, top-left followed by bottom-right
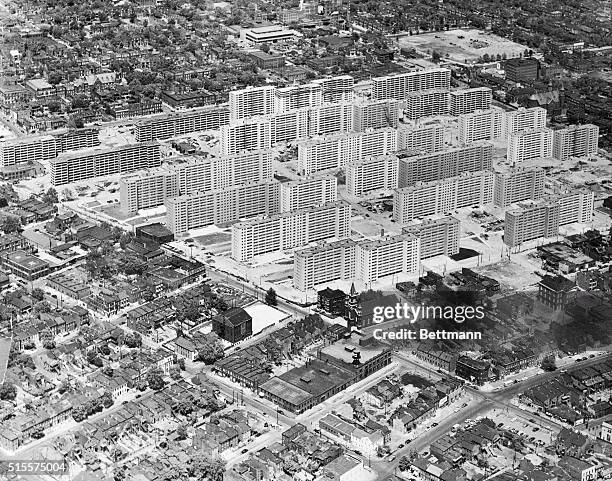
(399, 29), (526, 63)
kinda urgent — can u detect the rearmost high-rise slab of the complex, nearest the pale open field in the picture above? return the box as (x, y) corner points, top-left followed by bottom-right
(372, 68), (450, 100)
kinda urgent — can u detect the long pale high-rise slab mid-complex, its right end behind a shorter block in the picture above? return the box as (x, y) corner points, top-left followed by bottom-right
(298, 128), (397, 175)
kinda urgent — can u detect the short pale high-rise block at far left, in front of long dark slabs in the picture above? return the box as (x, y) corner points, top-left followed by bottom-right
(119, 168), (179, 214)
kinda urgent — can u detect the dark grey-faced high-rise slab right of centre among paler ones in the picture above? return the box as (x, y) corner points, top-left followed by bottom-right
(397, 143), (493, 187)
